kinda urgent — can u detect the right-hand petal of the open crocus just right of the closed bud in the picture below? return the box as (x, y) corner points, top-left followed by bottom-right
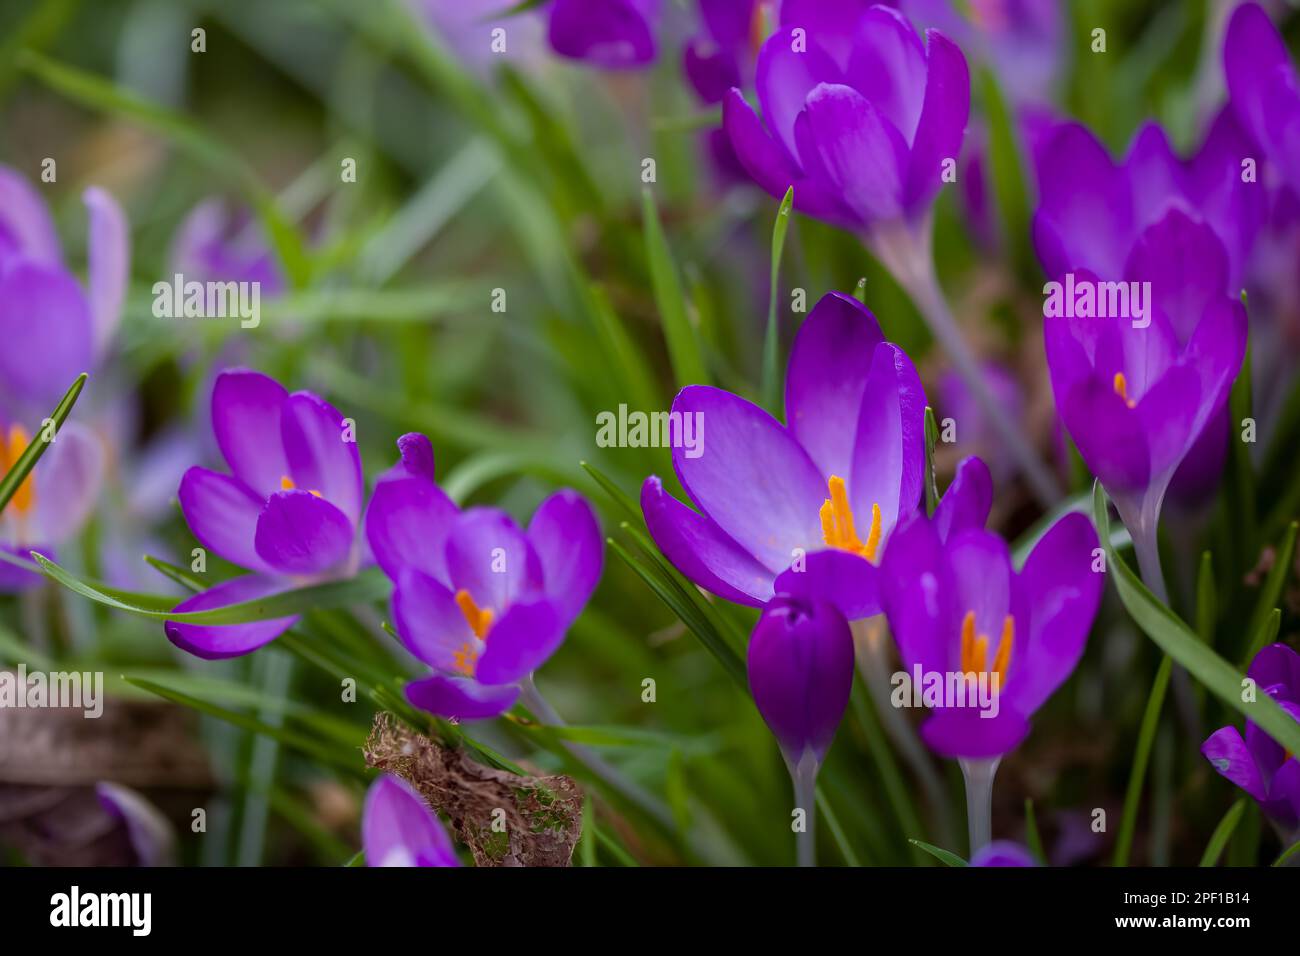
(1006, 512), (1104, 714)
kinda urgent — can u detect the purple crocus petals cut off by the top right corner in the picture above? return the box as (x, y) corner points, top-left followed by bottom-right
(1223, 4), (1300, 195)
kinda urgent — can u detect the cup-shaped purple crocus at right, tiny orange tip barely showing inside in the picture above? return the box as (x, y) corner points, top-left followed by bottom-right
(1044, 209), (1247, 535)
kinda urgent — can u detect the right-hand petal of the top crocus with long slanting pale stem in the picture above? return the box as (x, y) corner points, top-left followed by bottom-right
(904, 30), (971, 212)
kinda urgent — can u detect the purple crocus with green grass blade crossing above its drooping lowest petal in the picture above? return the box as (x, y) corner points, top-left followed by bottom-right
(166, 369), (365, 659)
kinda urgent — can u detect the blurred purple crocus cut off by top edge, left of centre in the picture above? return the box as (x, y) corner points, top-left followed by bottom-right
(547, 0), (659, 69)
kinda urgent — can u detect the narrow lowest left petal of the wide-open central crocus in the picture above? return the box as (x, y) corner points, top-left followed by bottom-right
(641, 475), (772, 606)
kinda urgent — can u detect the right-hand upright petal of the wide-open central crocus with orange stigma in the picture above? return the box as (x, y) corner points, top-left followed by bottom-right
(849, 342), (926, 531)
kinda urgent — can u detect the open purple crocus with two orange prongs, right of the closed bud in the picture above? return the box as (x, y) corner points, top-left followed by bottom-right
(880, 514), (1102, 760)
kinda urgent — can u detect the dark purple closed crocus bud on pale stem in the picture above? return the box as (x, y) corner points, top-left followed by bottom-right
(749, 596), (853, 769)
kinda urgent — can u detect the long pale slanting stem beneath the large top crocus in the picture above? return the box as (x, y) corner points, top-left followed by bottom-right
(866, 217), (1061, 507)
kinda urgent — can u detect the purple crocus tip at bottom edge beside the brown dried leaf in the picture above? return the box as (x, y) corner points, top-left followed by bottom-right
(361, 774), (460, 866)
